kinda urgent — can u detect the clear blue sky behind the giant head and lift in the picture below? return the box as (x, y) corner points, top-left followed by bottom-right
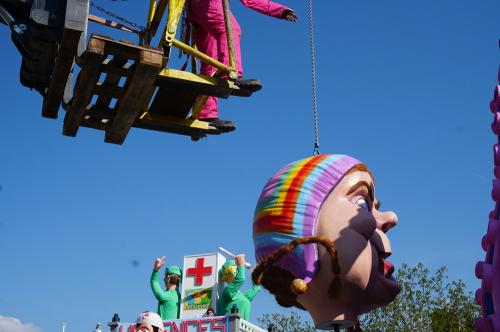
(0, 0), (500, 332)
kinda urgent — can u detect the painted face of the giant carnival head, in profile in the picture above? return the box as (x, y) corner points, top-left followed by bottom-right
(315, 171), (399, 312)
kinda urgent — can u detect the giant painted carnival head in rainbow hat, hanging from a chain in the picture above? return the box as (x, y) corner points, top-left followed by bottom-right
(252, 155), (399, 329)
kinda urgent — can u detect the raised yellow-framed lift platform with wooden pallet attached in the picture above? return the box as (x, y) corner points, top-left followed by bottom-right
(21, 0), (260, 144)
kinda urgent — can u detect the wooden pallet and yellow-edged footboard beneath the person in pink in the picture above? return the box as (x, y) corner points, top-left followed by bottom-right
(57, 34), (247, 144)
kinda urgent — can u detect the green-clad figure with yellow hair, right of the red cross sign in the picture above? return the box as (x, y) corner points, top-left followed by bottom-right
(217, 260), (260, 320)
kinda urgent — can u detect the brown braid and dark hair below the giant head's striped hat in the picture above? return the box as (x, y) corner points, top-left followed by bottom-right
(252, 236), (340, 309)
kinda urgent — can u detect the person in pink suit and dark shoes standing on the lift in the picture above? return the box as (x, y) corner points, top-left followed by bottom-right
(188, 0), (297, 131)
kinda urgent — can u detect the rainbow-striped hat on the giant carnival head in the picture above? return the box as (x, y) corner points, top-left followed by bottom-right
(253, 154), (361, 283)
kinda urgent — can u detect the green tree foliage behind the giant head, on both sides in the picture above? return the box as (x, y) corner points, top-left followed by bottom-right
(257, 263), (480, 332)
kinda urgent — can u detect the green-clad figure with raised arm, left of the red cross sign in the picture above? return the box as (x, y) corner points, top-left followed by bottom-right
(150, 264), (182, 320)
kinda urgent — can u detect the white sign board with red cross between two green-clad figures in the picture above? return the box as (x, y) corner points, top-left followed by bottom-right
(180, 253), (226, 319)
